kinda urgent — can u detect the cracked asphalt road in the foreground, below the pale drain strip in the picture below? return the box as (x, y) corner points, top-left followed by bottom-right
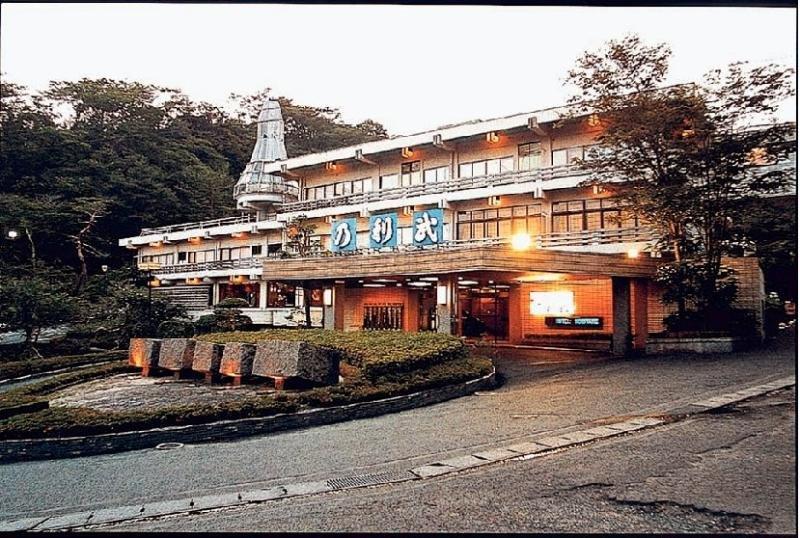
(111, 389), (797, 533)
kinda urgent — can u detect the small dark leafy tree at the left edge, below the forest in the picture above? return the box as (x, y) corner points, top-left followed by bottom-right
(0, 268), (80, 356)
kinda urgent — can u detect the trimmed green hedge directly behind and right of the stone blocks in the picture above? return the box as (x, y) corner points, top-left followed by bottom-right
(197, 329), (469, 380)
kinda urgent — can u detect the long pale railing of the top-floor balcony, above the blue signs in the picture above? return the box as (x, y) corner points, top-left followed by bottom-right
(281, 165), (588, 213)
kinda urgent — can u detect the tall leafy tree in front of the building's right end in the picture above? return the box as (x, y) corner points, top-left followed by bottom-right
(562, 35), (794, 326)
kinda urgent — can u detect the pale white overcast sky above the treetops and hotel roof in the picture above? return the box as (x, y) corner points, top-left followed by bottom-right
(0, 4), (797, 135)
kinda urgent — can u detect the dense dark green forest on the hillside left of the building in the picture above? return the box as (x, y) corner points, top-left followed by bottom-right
(0, 79), (386, 278)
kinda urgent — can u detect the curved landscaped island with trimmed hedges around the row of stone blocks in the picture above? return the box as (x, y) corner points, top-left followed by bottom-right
(0, 330), (492, 439)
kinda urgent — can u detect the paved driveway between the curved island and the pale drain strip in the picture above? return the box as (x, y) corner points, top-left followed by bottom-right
(0, 332), (795, 519)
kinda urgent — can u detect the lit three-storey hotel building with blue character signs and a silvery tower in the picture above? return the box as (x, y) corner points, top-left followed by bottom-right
(120, 96), (788, 352)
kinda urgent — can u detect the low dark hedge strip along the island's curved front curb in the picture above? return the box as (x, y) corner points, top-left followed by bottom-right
(0, 357), (492, 439)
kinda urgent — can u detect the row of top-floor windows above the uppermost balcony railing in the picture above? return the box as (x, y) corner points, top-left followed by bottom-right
(305, 142), (589, 200)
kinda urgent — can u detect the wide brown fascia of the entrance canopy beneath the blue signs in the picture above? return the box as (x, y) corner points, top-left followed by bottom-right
(262, 245), (662, 281)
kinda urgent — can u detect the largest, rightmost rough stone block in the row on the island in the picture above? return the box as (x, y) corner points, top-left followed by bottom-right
(253, 340), (339, 385)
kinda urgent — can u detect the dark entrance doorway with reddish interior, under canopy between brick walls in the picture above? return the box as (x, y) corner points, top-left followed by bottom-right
(458, 284), (509, 340)
